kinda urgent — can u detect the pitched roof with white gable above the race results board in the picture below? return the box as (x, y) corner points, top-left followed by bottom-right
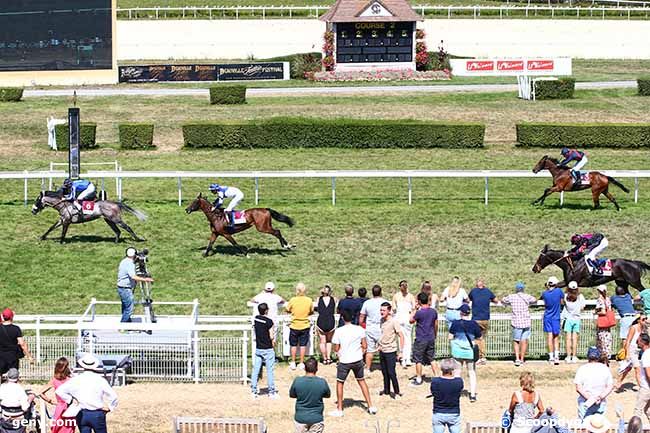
(319, 0), (423, 23)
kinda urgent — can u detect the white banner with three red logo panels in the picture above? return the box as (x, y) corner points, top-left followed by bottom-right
(450, 57), (571, 77)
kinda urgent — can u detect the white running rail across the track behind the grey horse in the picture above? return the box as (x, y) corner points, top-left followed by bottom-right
(0, 170), (650, 206)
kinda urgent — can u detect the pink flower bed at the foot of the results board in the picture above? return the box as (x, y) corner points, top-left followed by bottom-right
(306, 69), (451, 82)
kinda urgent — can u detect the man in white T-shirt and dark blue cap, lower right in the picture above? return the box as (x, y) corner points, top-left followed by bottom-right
(573, 347), (614, 421)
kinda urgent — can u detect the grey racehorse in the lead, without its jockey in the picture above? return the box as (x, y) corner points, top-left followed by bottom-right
(32, 191), (147, 243)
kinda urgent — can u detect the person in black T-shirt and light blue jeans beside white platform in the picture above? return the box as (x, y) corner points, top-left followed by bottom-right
(251, 302), (278, 399)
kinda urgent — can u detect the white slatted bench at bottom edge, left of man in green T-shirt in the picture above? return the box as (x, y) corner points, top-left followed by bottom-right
(172, 416), (266, 433)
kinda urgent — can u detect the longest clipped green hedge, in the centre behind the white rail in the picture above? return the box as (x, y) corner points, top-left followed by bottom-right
(183, 117), (485, 149)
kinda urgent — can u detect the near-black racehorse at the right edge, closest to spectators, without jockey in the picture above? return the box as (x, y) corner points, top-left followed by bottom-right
(533, 245), (650, 291)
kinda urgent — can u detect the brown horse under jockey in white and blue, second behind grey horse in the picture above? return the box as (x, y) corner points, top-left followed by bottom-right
(185, 193), (294, 257)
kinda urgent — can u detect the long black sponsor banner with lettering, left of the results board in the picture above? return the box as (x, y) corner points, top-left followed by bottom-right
(119, 62), (289, 83)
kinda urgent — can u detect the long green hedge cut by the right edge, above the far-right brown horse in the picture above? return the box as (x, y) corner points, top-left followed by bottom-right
(517, 123), (650, 148)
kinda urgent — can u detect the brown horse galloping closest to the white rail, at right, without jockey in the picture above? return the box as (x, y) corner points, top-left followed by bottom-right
(532, 155), (630, 210)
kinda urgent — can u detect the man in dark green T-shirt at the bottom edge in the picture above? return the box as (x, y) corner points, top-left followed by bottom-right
(289, 357), (331, 433)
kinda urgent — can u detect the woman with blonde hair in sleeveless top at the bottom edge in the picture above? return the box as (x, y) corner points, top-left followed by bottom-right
(508, 371), (544, 433)
